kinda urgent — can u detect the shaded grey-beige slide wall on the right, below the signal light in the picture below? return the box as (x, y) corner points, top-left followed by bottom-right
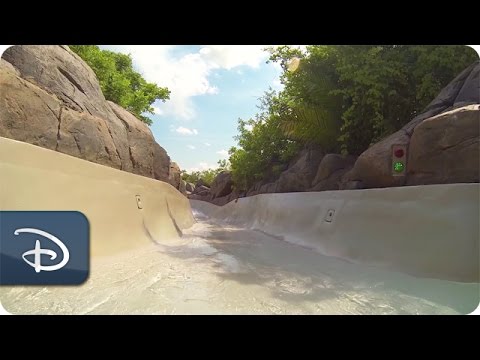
(191, 184), (480, 282)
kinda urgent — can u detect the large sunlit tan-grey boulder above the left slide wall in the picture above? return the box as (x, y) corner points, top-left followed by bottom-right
(0, 45), (175, 181)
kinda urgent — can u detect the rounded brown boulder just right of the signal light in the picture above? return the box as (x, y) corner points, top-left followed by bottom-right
(407, 105), (480, 185)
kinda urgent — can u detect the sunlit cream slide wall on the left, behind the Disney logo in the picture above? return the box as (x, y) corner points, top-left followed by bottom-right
(0, 137), (194, 256)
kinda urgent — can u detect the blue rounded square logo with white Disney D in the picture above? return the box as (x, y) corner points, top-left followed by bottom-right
(0, 211), (90, 285)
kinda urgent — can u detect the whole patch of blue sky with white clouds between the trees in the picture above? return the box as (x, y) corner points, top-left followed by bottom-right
(100, 45), (281, 171)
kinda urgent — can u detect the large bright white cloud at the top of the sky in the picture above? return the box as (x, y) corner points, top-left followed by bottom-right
(101, 45), (268, 119)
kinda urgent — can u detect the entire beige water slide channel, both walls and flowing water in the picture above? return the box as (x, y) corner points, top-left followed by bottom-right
(0, 138), (480, 314)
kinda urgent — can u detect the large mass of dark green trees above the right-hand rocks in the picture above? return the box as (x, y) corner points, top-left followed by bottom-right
(230, 45), (478, 187)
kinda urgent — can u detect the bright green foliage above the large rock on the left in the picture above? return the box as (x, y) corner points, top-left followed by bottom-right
(70, 45), (170, 125)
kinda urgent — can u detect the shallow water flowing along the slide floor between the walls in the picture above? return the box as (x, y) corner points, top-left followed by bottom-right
(0, 205), (479, 314)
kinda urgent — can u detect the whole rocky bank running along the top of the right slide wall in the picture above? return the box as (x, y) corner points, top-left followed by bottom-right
(202, 61), (480, 205)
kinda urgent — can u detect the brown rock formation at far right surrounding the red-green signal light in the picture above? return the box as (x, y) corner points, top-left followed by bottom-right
(348, 61), (480, 188)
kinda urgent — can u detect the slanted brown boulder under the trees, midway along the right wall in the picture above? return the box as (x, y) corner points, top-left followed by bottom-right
(275, 149), (324, 192)
